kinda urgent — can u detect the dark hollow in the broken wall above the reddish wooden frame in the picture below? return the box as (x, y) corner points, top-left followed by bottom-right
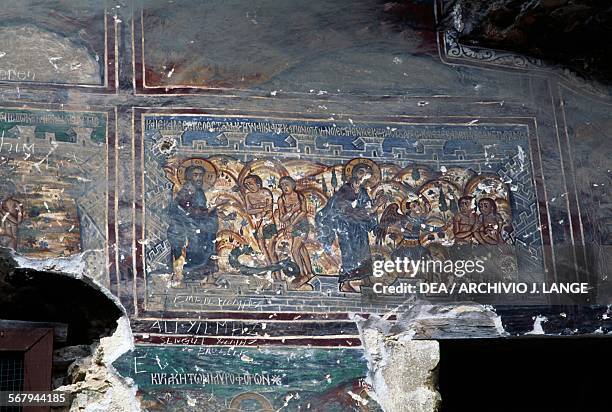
(0, 249), (122, 346)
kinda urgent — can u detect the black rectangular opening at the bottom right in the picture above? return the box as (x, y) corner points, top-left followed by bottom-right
(439, 337), (612, 412)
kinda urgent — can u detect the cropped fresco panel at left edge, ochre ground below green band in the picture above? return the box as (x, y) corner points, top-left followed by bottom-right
(0, 108), (110, 287)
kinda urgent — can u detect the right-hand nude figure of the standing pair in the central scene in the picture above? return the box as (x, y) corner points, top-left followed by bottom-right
(272, 176), (314, 288)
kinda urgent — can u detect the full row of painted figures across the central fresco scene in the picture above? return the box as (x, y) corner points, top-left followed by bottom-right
(168, 159), (512, 292)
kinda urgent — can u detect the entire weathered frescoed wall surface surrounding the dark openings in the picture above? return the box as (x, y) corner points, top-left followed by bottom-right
(0, 0), (612, 412)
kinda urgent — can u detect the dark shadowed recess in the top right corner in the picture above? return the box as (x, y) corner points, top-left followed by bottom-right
(442, 0), (612, 84)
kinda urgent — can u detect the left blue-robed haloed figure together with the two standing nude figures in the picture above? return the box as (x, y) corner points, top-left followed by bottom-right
(168, 164), (314, 288)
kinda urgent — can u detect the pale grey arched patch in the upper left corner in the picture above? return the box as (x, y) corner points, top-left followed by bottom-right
(0, 25), (101, 84)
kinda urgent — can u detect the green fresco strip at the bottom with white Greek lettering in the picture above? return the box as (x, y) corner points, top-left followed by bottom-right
(113, 346), (382, 412)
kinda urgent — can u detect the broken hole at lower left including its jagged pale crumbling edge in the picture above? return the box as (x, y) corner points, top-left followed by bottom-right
(0, 248), (139, 411)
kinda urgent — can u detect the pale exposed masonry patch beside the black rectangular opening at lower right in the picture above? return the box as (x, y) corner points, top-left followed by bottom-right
(355, 304), (506, 412)
